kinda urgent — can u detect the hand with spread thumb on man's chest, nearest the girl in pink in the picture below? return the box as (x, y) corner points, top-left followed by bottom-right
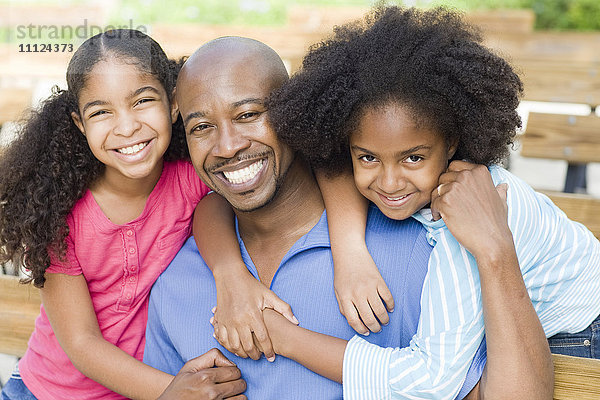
(211, 268), (298, 361)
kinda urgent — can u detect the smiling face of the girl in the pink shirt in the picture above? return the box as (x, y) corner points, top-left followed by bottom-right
(72, 58), (177, 179)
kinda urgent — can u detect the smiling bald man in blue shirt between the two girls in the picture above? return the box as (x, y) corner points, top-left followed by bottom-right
(144, 38), (483, 399)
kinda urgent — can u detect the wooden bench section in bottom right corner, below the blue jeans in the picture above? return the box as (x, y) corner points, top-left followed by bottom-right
(552, 354), (600, 400)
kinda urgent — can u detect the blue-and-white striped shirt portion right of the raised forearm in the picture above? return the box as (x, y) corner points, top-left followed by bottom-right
(490, 166), (600, 337)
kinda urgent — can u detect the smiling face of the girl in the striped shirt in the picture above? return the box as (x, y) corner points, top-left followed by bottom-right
(350, 102), (456, 220)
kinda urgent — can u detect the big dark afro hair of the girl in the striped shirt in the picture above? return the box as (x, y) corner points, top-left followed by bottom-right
(268, 6), (523, 174)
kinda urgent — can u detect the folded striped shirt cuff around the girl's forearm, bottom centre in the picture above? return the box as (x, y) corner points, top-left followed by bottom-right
(342, 335), (393, 399)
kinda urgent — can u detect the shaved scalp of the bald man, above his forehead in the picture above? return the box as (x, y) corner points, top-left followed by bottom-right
(177, 36), (289, 91)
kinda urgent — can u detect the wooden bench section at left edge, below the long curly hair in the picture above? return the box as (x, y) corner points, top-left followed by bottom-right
(0, 275), (41, 357)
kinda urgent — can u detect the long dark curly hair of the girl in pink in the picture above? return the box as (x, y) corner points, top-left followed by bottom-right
(0, 29), (189, 287)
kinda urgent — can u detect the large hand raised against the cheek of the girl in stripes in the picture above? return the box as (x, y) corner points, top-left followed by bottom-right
(431, 161), (514, 259)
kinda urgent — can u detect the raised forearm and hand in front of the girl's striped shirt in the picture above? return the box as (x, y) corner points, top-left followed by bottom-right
(432, 161), (554, 399)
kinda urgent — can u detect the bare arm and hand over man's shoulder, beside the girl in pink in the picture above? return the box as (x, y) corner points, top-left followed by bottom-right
(193, 193), (298, 361)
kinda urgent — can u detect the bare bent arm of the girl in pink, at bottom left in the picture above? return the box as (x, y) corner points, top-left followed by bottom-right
(40, 273), (173, 399)
